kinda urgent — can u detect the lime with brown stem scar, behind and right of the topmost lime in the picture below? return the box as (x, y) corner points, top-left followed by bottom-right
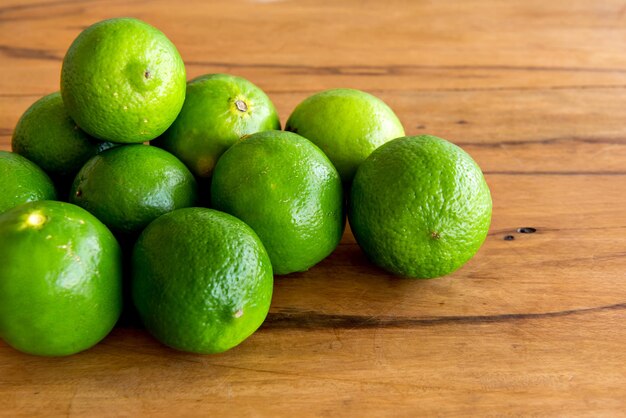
(153, 74), (280, 177)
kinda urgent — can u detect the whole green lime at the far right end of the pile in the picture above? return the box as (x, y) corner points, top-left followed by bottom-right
(348, 135), (491, 278)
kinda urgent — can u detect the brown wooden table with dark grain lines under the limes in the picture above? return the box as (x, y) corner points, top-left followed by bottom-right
(0, 0), (626, 417)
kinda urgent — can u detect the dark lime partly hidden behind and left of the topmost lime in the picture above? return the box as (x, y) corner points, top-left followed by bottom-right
(11, 92), (115, 180)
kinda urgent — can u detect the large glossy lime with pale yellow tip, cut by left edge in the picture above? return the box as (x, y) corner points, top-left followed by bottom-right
(0, 201), (122, 356)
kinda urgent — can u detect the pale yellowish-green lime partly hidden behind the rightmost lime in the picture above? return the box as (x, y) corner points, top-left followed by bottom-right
(285, 89), (404, 183)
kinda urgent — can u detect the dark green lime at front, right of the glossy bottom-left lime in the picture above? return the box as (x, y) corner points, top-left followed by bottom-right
(132, 208), (273, 354)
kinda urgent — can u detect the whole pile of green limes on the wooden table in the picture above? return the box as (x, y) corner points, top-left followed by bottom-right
(0, 18), (491, 356)
